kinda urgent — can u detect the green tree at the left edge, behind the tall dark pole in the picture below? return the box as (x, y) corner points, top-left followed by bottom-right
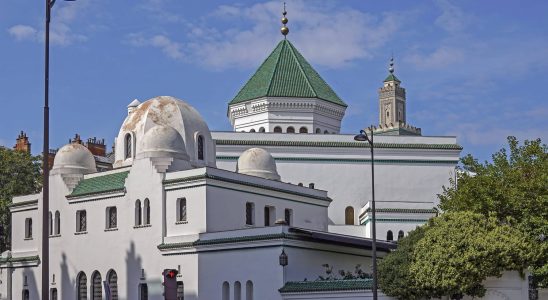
(0, 147), (42, 252)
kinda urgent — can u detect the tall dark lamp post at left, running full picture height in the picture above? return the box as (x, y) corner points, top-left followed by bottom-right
(41, 0), (74, 300)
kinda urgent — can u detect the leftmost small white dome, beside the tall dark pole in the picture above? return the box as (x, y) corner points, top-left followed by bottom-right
(52, 143), (97, 174)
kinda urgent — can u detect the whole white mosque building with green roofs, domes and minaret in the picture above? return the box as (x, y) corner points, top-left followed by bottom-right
(0, 8), (527, 300)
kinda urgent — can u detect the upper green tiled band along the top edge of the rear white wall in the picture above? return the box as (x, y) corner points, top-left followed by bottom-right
(215, 139), (462, 150)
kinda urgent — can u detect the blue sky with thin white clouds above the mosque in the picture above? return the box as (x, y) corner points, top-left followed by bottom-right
(0, 0), (548, 159)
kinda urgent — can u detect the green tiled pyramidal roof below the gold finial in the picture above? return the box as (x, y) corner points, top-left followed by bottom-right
(229, 39), (347, 107)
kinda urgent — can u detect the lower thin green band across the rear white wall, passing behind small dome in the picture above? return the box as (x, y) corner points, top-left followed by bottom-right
(217, 156), (459, 165)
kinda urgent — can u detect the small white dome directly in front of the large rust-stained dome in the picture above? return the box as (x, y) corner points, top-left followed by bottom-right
(139, 125), (189, 160)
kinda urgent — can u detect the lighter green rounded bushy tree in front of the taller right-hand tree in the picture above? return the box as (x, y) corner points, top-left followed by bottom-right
(408, 212), (535, 299)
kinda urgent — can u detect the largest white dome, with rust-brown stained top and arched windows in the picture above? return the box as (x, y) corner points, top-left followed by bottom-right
(114, 96), (215, 167)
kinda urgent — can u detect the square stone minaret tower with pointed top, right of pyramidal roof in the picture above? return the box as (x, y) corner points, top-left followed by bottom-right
(375, 57), (421, 135)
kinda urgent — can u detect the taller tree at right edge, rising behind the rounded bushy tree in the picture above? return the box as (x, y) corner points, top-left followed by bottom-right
(439, 137), (548, 286)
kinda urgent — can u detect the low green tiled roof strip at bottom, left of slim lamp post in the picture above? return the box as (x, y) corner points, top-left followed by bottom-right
(279, 279), (372, 293)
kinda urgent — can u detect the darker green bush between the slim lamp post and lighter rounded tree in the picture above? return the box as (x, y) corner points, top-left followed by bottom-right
(379, 227), (426, 300)
